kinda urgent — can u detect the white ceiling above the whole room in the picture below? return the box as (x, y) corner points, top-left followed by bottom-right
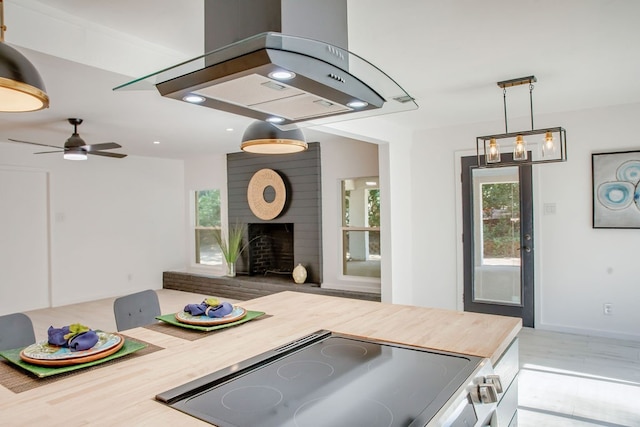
(0, 0), (640, 158)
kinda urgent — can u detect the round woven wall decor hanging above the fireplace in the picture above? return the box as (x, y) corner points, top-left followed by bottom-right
(247, 169), (287, 221)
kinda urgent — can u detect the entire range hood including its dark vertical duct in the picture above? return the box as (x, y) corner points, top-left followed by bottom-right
(114, 0), (418, 129)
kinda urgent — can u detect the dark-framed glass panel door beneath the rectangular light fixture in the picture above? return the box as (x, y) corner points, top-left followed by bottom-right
(462, 156), (534, 327)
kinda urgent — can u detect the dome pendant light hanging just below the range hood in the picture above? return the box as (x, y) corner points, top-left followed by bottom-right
(240, 120), (308, 154)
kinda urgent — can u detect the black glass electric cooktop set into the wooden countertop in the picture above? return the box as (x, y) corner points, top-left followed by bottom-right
(156, 331), (481, 427)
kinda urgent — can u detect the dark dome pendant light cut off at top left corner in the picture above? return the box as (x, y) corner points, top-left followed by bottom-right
(0, 0), (49, 112)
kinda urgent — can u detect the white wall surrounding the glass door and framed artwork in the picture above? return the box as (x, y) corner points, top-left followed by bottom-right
(411, 104), (640, 339)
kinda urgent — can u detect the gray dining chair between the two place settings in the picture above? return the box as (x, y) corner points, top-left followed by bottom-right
(113, 289), (160, 331)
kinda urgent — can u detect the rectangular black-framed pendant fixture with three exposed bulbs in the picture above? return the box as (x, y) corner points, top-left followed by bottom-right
(476, 76), (567, 167)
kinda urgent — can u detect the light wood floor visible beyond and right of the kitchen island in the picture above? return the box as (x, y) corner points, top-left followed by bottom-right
(26, 289), (640, 427)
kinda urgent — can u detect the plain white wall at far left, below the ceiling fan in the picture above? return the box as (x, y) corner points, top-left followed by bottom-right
(0, 143), (185, 309)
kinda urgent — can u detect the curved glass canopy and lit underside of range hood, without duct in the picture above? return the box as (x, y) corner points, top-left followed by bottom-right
(114, 2), (418, 129)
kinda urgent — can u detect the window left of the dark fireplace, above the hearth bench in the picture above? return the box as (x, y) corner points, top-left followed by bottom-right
(194, 190), (222, 266)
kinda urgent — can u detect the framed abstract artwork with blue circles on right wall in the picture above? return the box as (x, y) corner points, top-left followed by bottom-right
(591, 150), (640, 228)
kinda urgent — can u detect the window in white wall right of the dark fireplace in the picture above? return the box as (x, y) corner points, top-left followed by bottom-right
(342, 176), (380, 278)
